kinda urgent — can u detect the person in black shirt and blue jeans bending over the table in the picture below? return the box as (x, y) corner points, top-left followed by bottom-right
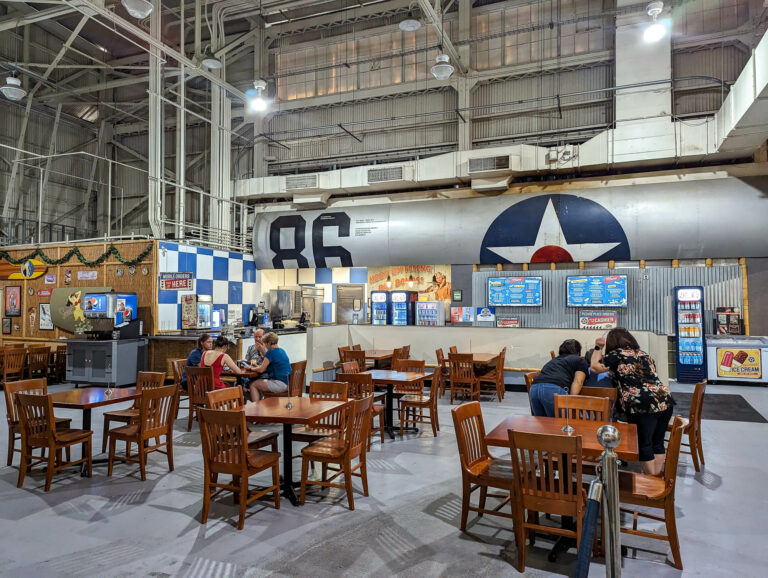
(530, 339), (589, 417)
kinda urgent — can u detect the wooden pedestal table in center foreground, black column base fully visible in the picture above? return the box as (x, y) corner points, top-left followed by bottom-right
(245, 397), (347, 506)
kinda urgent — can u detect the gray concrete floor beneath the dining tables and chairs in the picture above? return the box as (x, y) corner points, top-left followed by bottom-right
(0, 385), (768, 578)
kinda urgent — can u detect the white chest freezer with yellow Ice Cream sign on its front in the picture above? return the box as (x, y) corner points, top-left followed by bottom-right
(707, 335), (768, 384)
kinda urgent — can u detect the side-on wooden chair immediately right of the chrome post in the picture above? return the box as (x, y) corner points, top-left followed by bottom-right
(619, 416), (685, 570)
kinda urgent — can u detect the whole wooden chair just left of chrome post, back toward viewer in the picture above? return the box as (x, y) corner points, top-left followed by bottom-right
(509, 430), (586, 572)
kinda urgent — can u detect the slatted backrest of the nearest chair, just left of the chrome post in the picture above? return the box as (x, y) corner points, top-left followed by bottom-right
(508, 430), (584, 517)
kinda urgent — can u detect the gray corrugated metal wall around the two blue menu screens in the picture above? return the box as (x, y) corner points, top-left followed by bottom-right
(472, 265), (742, 335)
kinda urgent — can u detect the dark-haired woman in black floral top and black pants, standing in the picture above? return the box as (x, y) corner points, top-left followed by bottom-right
(590, 327), (675, 475)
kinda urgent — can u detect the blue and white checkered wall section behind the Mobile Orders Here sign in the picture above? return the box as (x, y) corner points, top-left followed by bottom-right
(158, 241), (261, 331)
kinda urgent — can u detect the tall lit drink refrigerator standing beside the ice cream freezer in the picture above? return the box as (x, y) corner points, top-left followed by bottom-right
(674, 287), (707, 383)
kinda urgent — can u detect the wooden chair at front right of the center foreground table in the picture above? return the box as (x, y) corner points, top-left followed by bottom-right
(300, 396), (373, 510)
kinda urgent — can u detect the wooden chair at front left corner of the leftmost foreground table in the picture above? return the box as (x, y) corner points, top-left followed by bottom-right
(16, 393), (93, 492)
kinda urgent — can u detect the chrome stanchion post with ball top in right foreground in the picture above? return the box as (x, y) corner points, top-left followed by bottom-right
(597, 424), (621, 578)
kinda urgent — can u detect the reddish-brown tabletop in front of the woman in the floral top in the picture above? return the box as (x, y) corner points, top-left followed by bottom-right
(485, 415), (639, 461)
